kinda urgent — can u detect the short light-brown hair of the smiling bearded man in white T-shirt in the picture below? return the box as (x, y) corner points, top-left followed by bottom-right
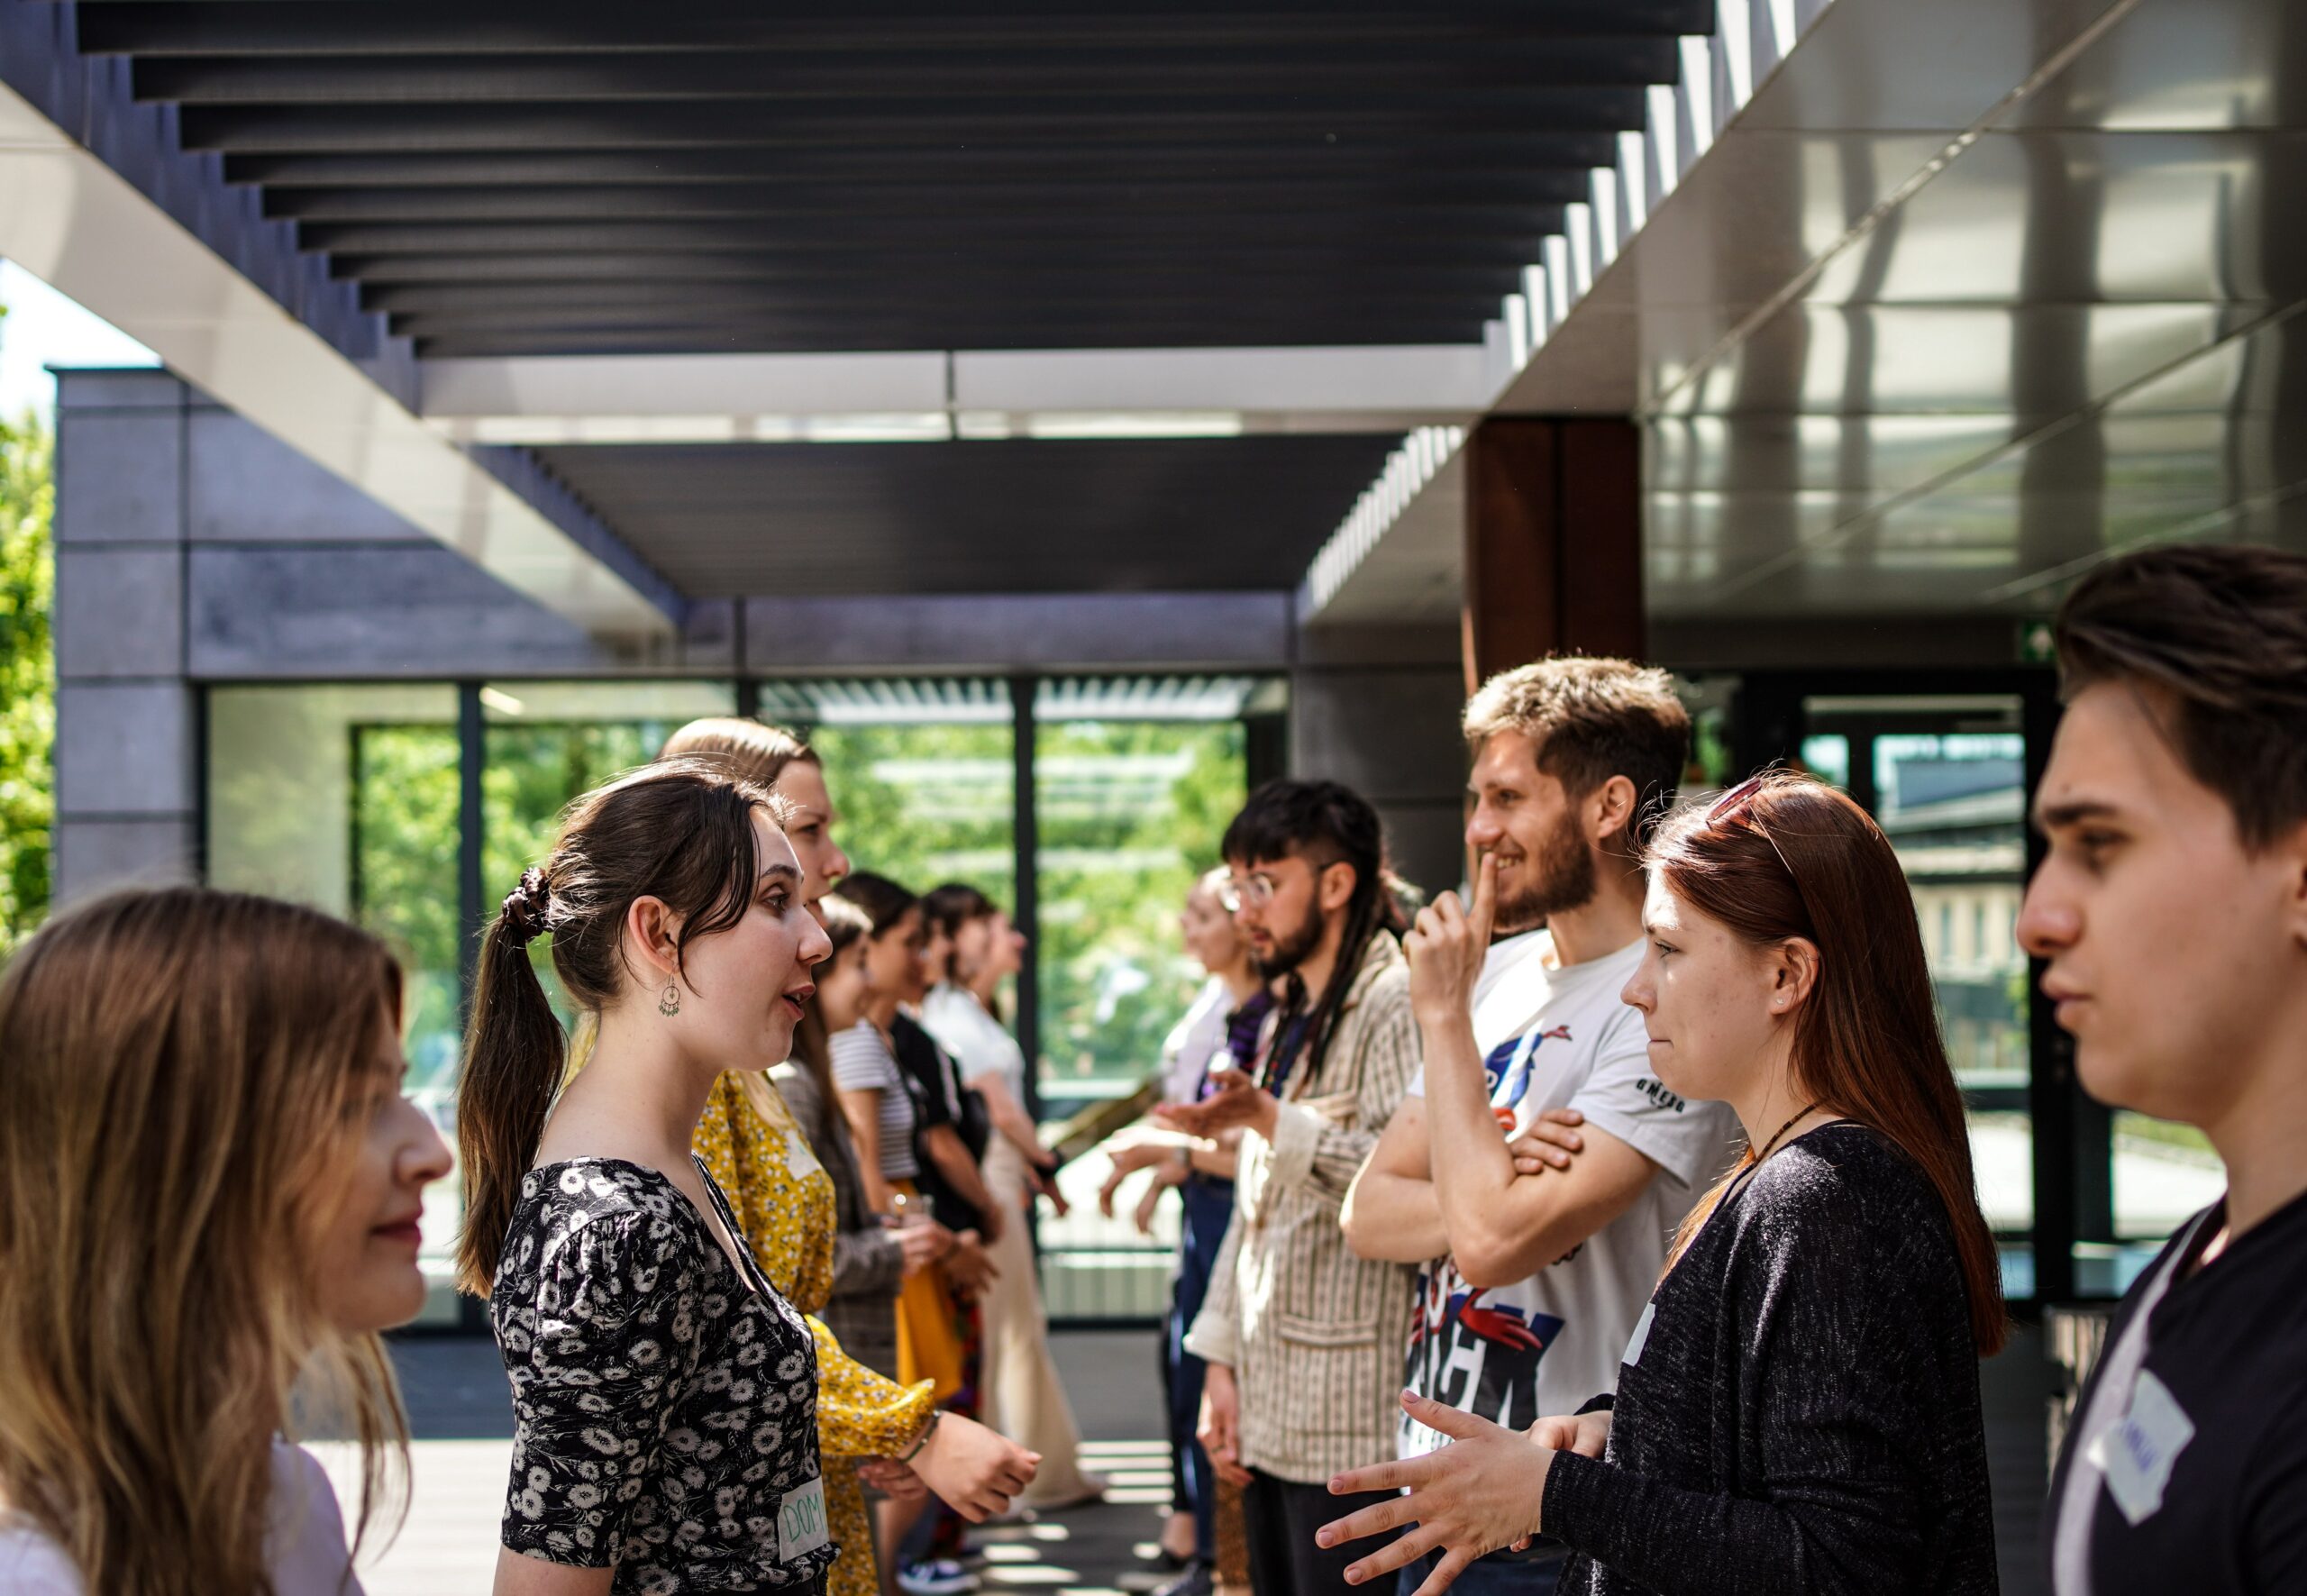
(1465, 655), (1691, 849)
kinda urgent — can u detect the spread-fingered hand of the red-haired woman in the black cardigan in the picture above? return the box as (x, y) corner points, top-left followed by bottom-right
(1315, 1391), (1560, 1596)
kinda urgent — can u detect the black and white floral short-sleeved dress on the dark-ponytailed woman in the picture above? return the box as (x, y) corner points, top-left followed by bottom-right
(489, 1158), (837, 1596)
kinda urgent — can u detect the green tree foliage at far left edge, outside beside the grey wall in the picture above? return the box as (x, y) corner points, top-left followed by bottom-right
(0, 406), (55, 944)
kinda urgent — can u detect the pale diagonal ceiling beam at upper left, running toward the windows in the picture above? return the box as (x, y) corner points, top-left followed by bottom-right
(0, 75), (674, 646)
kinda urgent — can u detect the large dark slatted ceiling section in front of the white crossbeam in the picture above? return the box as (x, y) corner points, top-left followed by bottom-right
(78, 0), (1712, 355)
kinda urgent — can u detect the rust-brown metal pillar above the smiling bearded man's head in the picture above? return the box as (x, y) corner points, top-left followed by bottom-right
(1460, 417), (1645, 692)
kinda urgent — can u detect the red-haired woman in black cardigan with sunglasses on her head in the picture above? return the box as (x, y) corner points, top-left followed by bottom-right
(1322, 772), (2005, 1596)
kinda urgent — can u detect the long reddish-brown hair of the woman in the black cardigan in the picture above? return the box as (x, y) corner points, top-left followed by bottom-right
(1649, 771), (2010, 1356)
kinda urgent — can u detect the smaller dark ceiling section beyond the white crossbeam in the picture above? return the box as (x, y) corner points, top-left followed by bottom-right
(537, 436), (1393, 597)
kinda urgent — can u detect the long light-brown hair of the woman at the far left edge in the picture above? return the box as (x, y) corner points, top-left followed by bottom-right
(0, 888), (408, 1596)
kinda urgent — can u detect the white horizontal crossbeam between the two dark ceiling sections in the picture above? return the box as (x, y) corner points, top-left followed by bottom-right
(422, 343), (1497, 442)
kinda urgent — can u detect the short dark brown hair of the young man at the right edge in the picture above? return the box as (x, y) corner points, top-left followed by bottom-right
(2053, 544), (2307, 851)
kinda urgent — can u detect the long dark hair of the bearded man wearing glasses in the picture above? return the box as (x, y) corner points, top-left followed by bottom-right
(1220, 777), (1398, 1072)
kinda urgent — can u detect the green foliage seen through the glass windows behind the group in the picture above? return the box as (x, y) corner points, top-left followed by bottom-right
(336, 722), (1244, 1100)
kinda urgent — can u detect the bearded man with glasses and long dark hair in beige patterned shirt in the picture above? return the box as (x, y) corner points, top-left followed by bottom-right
(1163, 782), (1418, 1596)
